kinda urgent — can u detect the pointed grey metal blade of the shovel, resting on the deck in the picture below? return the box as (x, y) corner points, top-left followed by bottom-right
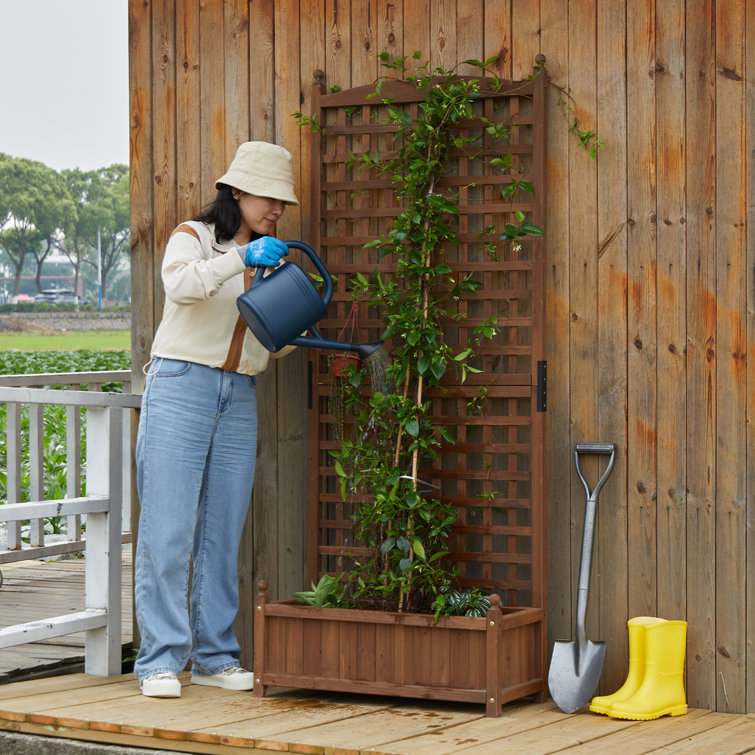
(548, 640), (606, 713)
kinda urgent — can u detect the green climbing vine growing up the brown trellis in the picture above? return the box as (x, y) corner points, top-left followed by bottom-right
(295, 53), (542, 614)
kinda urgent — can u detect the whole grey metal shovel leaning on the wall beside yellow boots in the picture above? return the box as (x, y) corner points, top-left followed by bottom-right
(548, 443), (618, 713)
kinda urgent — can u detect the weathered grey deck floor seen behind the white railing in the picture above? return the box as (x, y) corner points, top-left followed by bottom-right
(0, 546), (132, 683)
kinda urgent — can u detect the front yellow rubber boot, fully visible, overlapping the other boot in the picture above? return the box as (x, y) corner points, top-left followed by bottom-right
(607, 621), (687, 721)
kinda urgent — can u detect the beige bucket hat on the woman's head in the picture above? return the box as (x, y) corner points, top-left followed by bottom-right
(215, 142), (299, 204)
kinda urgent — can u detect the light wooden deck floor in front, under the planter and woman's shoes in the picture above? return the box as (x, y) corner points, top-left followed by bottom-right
(0, 674), (755, 755)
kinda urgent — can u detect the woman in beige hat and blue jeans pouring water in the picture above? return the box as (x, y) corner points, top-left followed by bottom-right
(134, 142), (298, 697)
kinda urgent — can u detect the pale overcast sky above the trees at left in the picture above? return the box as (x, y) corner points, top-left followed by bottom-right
(0, 0), (129, 170)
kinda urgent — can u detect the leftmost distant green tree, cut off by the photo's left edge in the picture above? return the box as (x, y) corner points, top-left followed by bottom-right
(0, 154), (76, 299)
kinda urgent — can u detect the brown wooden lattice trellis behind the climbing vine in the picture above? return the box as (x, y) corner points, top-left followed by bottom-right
(309, 72), (545, 607)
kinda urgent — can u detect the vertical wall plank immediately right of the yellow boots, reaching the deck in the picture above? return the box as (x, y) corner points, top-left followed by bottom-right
(685, 0), (717, 707)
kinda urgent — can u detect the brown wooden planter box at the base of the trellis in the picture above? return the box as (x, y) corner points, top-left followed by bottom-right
(254, 582), (545, 716)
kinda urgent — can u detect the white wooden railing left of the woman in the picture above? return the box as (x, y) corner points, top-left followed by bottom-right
(0, 373), (141, 676)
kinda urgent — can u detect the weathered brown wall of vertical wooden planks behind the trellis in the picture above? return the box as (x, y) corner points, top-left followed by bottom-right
(129, 0), (755, 712)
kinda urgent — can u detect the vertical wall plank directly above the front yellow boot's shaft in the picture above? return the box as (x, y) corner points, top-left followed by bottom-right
(655, 2), (687, 628)
